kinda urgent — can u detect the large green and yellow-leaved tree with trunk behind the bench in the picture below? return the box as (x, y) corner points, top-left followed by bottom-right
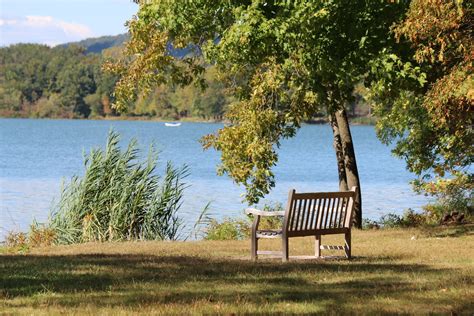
(106, 0), (406, 227)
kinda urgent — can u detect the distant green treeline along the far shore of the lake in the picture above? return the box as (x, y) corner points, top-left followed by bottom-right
(0, 35), (368, 120)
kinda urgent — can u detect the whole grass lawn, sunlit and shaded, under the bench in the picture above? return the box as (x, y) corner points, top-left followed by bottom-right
(0, 226), (474, 315)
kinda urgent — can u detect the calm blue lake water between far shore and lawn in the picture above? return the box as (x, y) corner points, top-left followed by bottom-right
(0, 119), (427, 240)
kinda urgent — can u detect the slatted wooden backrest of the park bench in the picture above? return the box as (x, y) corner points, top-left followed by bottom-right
(283, 187), (356, 236)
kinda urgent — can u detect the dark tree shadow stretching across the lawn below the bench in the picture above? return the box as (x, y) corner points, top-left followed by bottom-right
(0, 255), (470, 312)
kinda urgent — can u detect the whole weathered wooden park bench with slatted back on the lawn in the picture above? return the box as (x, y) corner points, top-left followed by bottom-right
(245, 187), (356, 262)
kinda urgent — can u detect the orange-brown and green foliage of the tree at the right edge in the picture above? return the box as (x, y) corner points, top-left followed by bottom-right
(369, 0), (474, 216)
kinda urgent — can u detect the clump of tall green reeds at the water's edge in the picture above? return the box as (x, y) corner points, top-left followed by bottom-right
(50, 131), (189, 244)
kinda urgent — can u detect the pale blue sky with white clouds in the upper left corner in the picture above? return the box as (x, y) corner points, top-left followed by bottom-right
(0, 0), (138, 46)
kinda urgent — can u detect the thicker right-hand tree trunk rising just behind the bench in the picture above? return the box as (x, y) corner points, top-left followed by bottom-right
(333, 110), (362, 228)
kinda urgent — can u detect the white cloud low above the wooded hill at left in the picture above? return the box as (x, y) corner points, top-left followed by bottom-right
(0, 15), (94, 46)
